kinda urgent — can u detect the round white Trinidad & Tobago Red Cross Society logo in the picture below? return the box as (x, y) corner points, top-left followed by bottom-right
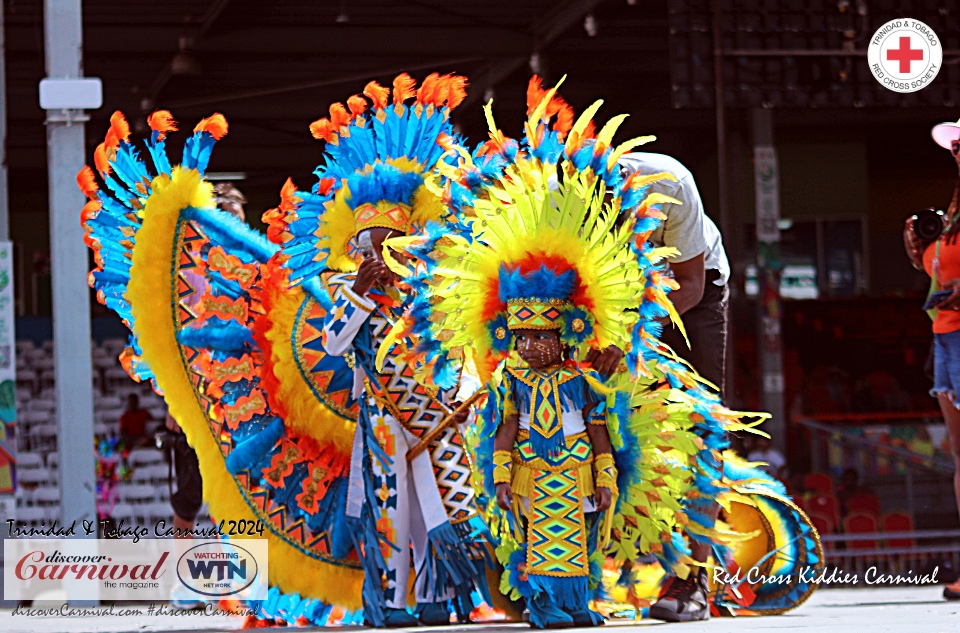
(867, 18), (943, 93)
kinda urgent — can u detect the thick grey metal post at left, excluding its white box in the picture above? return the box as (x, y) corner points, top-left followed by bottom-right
(44, 0), (97, 592)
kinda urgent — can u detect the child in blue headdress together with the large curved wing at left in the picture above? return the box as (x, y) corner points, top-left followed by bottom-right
(78, 74), (492, 626)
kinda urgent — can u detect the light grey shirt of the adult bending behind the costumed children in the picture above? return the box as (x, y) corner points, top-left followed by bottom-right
(619, 152), (730, 286)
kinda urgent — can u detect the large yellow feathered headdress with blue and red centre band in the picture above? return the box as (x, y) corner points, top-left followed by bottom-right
(378, 77), (680, 380)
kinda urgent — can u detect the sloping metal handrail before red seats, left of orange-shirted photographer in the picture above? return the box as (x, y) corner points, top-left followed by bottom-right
(798, 413), (954, 516)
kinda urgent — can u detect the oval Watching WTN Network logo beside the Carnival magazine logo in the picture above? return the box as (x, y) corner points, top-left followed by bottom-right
(177, 541), (258, 597)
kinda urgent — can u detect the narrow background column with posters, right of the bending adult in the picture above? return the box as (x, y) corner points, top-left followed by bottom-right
(751, 109), (787, 454)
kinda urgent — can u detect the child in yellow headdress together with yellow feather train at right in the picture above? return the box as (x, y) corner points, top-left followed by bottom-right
(384, 77), (822, 627)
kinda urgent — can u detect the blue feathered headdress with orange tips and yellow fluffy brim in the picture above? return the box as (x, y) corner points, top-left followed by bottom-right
(264, 73), (467, 284)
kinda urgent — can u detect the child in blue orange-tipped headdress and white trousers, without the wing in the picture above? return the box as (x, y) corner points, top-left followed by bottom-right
(289, 75), (485, 627)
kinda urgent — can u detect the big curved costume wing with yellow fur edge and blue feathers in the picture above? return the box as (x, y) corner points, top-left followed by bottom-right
(78, 112), (363, 622)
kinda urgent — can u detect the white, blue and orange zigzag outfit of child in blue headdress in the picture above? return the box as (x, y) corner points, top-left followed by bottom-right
(323, 273), (483, 609)
